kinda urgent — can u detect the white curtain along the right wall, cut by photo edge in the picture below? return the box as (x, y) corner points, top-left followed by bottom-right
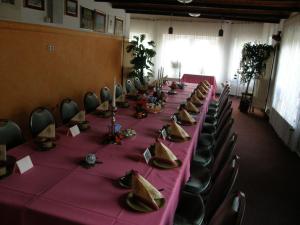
(273, 16), (300, 152)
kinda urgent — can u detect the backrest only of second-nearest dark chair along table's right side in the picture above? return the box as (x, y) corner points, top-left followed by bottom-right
(205, 156), (239, 221)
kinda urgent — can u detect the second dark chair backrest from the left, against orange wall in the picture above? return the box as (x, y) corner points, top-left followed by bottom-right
(29, 107), (55, 137)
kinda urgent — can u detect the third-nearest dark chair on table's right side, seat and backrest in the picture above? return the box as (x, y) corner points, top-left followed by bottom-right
(185, 133), (237, 195)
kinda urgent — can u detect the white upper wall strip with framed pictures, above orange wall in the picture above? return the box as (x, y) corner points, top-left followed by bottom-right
(0, 0), (130, 37)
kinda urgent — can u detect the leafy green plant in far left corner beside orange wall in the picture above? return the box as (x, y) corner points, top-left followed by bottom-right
(126, 34), (156, 84)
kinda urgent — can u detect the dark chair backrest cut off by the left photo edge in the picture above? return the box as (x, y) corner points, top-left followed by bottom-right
(0, 120), (24, 150)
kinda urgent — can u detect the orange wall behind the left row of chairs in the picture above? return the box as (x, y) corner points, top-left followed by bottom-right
(0, 21), (122, 136)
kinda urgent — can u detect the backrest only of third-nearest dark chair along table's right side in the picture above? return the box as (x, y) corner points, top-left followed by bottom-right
(211, 133), (238, 181)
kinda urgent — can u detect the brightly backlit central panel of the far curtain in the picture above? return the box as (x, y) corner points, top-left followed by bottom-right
(161, 34), (222, 78)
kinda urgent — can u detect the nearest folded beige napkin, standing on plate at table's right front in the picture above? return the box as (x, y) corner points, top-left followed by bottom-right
(132, 171), (163, 210)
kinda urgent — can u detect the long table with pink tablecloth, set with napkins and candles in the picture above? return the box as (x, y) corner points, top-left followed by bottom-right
(0, 84), (211, 225)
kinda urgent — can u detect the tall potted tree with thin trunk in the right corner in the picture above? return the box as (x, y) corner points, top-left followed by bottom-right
(235, 42), (273, 112)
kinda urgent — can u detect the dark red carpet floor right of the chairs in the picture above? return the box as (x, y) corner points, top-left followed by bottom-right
(232, 97), (300, 225)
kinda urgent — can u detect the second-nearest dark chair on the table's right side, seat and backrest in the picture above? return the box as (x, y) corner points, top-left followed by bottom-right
(174, 157), (239, 225)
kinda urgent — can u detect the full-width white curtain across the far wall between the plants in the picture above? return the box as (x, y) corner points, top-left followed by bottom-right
(130, 19), (275, 94)
